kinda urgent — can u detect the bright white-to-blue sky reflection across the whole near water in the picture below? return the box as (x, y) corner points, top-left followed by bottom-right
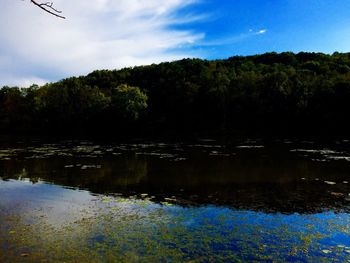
(0, 180), (350, 262)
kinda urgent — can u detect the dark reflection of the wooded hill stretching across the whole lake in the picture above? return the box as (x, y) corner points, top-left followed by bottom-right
(0, 153), (349, 213)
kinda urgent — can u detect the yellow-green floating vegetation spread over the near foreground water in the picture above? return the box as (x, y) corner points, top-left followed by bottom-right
(0, 182), (350, 262)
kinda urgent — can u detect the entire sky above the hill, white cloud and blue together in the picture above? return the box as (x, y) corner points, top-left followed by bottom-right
(0, 0), (350, 87)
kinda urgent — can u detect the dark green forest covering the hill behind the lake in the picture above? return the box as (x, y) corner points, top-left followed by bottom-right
(0, 52), (350, 137)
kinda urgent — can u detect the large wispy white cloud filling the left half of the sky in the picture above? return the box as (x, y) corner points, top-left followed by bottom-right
(0, 0), (204, 86)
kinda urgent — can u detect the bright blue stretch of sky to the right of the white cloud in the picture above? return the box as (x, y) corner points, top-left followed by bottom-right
(180, 0), (350, 58)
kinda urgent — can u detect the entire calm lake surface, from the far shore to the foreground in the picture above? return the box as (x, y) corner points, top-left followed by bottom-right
(0, 140), (350, 262)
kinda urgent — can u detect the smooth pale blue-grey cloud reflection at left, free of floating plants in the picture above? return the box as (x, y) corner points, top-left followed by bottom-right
(0, 180), (92, 225)
